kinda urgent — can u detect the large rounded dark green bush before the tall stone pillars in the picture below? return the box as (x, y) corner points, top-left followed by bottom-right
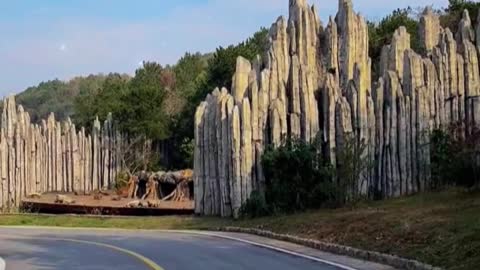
(262, 140), (334, 213)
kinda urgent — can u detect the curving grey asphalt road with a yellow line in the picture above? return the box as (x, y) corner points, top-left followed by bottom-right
(0, 228), (341, 270)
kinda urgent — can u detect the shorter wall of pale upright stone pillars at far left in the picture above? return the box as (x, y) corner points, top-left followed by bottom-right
(0, 97), (123, 210)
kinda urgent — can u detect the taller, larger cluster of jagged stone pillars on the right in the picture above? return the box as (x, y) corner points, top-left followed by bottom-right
(194, 0), (480, 216)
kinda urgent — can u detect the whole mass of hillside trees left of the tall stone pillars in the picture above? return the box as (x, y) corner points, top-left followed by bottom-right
(18, 29), (268, 171)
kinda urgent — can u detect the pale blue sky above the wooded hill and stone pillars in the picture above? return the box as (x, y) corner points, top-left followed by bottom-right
(0, 0), (448, 96)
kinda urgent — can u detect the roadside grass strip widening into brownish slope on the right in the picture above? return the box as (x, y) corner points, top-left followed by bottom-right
(0, 190), (480, 270)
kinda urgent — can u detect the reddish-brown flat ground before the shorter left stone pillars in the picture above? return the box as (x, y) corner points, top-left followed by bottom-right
(23, 192), (194, 210)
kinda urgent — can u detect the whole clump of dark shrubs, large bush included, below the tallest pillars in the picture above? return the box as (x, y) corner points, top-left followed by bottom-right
(241, 134), (373, 217)
